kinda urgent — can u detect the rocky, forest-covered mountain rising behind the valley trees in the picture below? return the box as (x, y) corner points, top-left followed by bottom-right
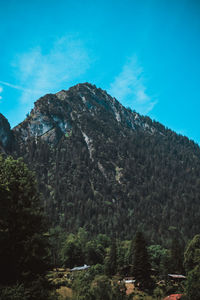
(0, 83), (200, 243)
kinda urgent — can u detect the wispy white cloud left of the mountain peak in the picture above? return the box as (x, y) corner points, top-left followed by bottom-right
(11, 37), (91, 104)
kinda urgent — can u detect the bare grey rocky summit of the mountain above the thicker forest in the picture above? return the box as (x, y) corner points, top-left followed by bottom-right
(14, 83), (155, 144)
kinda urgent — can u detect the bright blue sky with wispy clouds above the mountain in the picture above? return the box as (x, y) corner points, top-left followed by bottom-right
(0, 0), (200, 143)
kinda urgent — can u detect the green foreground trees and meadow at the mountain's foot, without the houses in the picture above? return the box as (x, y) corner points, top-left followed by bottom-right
(0, 156), (200, 300)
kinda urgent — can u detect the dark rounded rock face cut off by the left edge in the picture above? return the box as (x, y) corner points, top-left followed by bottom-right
(0, 114), (12, 151)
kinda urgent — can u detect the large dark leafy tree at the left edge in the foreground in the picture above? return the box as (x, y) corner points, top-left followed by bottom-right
(0, 156), (49, 292)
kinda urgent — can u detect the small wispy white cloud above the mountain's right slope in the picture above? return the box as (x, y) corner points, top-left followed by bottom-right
(109, 56), (157, 114)
